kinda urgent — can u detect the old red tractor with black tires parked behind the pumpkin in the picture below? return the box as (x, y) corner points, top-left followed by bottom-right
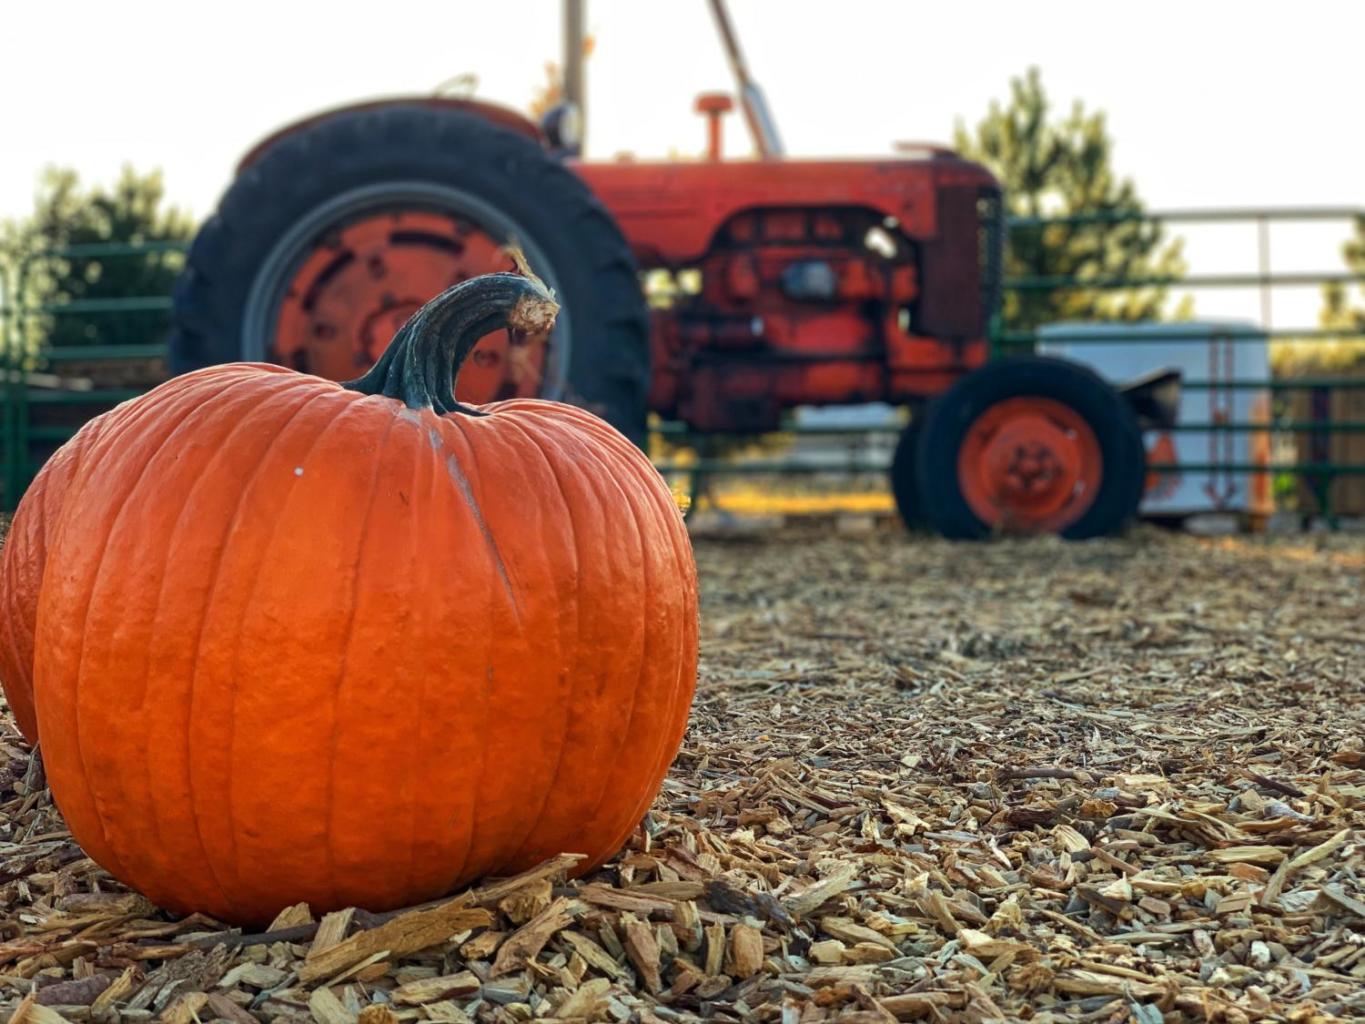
(172, 0), (1158, 538)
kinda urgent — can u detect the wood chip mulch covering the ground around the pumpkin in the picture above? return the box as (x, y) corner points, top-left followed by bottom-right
(0, 530), (1365, 1024)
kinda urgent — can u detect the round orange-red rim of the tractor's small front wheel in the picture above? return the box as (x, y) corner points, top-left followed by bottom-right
(957, 397), (1104, 534)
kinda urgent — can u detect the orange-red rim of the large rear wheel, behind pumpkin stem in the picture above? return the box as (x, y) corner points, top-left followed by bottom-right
(270, 210), (546, 404)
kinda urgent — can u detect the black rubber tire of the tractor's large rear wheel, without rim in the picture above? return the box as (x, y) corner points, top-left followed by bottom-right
(171, 104), (650, 444)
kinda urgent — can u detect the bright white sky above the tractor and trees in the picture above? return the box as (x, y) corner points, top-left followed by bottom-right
(0, 0), (1365, 326)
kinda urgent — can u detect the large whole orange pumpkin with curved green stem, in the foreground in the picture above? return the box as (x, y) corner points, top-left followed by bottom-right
(34, 274), (698, 923)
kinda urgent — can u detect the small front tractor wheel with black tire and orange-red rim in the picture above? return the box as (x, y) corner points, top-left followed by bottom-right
(916, 356), (1145, 539)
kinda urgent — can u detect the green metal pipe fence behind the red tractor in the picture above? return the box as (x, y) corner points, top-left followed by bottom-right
(0, 209), (1365, 523)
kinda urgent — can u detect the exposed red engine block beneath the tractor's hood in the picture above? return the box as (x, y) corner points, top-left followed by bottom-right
(651, 208), (919, 431)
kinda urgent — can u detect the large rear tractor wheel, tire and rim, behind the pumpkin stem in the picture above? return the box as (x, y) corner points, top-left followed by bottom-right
(171, 104), (650, 445)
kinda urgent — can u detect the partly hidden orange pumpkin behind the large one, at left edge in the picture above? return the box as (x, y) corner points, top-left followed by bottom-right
(0, 416), (104, 744)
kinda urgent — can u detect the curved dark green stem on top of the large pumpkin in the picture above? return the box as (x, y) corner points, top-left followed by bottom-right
(341, 273), (560, 416)
